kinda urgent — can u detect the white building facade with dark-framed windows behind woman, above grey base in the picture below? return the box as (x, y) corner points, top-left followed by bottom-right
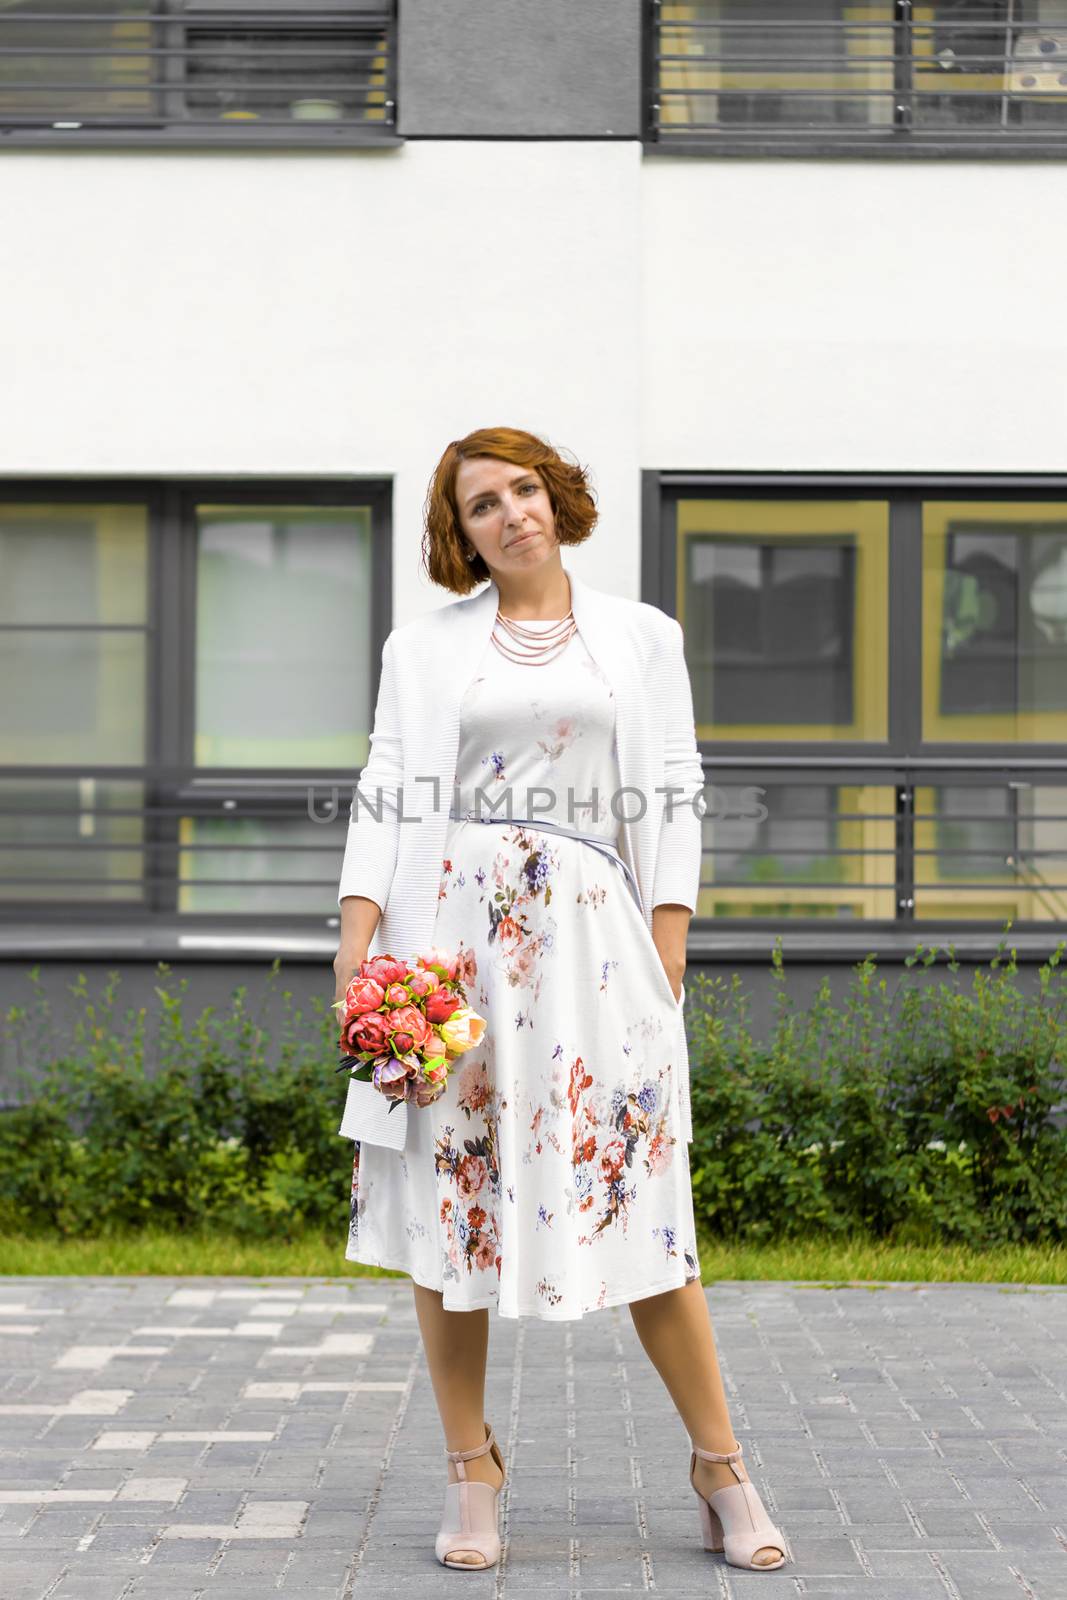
(0, 0), (1067, 1024)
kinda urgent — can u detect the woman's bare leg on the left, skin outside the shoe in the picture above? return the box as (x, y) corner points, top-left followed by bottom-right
(411, 1280), (502, 1566)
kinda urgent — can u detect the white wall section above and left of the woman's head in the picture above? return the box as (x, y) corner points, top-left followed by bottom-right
(0, 141), (641, 622)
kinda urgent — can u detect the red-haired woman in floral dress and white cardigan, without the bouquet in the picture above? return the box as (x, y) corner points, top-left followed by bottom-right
(334, 429), (785, 1568)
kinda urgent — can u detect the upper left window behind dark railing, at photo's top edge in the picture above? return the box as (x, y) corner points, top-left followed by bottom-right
(0, 0), (398, 149)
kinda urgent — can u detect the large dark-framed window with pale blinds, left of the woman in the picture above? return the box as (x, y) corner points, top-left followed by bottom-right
(0, 485), (392, 920)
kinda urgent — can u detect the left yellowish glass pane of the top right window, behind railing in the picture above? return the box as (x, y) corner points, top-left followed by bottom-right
(657, 0), (894, 133)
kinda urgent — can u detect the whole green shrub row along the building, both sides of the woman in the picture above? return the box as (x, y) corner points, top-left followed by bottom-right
(0, 942), (1067, 1246)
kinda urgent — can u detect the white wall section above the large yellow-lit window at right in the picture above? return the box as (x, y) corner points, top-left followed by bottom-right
(641, 157), (1067, 472)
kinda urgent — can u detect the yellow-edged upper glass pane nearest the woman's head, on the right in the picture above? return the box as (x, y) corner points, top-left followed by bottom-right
(677, 499), (889, 742)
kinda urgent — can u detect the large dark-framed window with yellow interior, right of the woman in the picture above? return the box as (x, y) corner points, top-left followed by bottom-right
(645, 474), (1067, 928)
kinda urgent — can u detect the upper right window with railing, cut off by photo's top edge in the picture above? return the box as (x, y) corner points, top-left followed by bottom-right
(648, 0), (1067, 155)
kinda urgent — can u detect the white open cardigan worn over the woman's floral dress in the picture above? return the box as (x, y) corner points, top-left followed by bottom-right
(338, 568), (707, 1142)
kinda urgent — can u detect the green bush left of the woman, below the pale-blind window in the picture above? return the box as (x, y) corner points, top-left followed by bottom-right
(0, 962), (343, 1238)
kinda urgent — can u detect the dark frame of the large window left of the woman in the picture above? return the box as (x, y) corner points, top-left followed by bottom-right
(0, 475), (394, 934)
